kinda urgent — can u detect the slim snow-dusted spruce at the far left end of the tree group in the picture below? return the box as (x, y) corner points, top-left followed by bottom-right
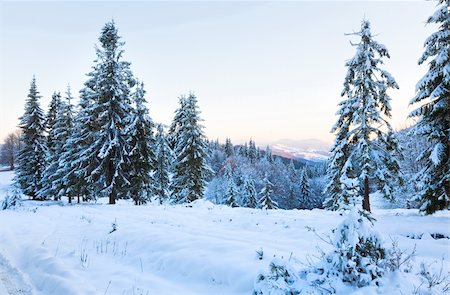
(16, 77), (47, 200)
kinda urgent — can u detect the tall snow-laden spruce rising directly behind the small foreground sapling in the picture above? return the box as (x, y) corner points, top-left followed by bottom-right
(326, 20), (401, 211)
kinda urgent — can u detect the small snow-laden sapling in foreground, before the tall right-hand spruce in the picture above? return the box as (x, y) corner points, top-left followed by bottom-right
(300, 175), (389, 289)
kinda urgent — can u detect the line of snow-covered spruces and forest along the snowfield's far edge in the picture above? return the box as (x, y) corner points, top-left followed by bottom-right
(5, 2), (450, 220)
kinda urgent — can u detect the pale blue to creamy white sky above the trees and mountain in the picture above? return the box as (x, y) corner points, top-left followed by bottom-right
(0, 1), (436, 143)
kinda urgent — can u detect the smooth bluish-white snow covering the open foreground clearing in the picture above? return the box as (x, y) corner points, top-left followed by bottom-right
(0, 172), (450, 295)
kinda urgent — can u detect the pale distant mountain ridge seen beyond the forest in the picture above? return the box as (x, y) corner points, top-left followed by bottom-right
(269, 138), (331, 161)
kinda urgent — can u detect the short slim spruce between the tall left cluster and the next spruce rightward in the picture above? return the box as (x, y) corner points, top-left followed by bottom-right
(154, 124), (173, 204)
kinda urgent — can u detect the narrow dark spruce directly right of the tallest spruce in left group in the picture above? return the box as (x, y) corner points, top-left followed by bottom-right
(124, 83), (155, 205)
